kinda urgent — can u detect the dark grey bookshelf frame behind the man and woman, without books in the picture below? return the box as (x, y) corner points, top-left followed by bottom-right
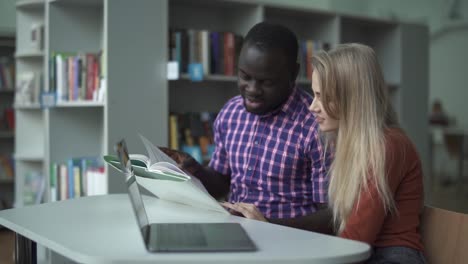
(165, 0), (429, 177)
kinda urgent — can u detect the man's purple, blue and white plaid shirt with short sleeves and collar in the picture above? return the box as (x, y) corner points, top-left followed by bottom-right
(209, 88), (328, 218)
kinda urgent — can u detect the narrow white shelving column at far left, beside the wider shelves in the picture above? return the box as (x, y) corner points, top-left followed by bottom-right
(15, 0), (46, 207)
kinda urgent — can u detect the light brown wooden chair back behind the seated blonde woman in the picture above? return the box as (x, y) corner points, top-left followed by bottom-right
(421, 206), (468, 264)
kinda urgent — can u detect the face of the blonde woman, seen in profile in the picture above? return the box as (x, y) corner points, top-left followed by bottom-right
(309, 71), (338, 132)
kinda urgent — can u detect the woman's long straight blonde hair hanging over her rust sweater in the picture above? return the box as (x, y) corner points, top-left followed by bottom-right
(312, 43), (398, 232)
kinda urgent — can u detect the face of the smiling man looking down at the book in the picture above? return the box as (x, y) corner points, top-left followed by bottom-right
(238, 44), (294, 115)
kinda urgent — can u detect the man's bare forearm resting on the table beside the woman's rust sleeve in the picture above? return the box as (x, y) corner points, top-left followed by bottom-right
(268, 208), (334, 235)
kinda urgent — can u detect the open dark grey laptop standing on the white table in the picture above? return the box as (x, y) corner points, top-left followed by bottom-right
(115, 139), (256, 252)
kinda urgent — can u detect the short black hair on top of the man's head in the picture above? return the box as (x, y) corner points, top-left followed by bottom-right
(244, 22), (299, 65)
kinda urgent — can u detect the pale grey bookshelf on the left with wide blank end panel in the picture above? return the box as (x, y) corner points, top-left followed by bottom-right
(14, 0), (168, 212)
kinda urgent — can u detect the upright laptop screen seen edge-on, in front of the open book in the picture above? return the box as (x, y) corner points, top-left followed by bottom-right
(115, 139), (149, 242)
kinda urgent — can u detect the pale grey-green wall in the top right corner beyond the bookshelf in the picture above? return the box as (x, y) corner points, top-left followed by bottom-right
(369, 0), (468, 130)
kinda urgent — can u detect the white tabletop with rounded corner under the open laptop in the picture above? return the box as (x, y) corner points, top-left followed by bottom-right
(0, 194), (370, 264)
